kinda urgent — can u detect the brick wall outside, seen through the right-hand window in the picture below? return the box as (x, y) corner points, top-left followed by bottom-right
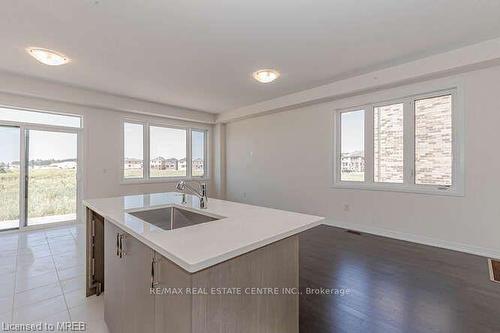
(372, 95), (452, 185)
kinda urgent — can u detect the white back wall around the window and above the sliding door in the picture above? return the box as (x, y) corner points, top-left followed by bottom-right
(0, 92), (214, 205)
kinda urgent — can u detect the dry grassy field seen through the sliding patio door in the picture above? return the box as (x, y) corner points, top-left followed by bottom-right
(0, 169), (76, 221)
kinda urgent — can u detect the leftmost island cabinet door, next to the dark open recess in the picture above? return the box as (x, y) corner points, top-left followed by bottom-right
(104, 222), (124, 333)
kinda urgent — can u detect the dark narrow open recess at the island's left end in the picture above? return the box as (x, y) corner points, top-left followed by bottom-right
(85, 208), (104, 297)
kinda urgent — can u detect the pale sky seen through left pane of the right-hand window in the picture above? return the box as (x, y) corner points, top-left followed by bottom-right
(340, 110), (365, 153)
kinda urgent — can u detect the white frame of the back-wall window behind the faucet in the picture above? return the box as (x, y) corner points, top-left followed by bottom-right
(120, 118), (210, 184)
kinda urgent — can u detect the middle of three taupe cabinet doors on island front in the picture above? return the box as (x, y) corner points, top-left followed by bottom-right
(122, 235), (155, 333)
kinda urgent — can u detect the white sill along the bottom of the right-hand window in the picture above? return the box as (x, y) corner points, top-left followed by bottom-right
(330, 182), (465, 197)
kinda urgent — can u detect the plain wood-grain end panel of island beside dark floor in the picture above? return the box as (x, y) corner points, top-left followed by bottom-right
(192, 236), (299, 333)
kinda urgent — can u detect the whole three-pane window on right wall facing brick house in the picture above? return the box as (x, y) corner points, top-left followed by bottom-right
(333, 89), (464, 195)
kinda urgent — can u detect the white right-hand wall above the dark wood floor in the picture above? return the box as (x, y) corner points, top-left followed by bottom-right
(226, 67), (500, 257)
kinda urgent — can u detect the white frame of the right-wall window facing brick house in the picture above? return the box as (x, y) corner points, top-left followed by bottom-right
(332, 86), (465, 196)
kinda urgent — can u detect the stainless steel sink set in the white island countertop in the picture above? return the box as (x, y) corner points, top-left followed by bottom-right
(129, 207), (219, 230)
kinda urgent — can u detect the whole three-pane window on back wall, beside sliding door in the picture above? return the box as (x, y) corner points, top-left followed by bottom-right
(123, 122), (208, 182)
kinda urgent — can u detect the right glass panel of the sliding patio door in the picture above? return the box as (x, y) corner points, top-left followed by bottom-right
(27, 130), (77, 225)
